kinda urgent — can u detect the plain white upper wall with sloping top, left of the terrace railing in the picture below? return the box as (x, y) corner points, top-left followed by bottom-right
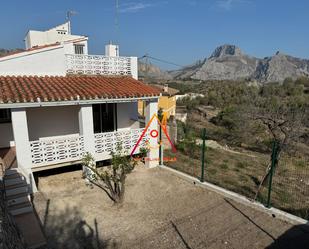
(0, 46), (66, 76)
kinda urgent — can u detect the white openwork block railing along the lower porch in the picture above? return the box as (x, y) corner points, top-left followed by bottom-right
(30, 129), (147, 167)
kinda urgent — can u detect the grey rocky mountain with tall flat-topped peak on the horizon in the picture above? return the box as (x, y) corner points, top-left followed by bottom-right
(170, 45), (309, 82)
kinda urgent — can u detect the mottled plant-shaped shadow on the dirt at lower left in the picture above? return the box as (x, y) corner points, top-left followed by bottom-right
(38, 200), (117, 249)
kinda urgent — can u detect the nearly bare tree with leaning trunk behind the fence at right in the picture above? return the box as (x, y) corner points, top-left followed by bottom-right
(243, 84), (308, 199)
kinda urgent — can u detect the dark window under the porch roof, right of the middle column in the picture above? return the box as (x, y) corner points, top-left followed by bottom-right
(92, 104), (117, 133)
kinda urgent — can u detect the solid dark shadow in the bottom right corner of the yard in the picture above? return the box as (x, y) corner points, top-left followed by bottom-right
(266, 223), (309, 249)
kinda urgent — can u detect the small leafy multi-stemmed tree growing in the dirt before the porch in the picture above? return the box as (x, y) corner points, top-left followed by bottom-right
(83, 143), (137, 204)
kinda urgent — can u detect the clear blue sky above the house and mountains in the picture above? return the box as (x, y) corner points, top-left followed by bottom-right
(0, 0), (309, 68)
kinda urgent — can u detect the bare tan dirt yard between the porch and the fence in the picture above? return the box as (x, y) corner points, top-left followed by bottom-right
(34, 166), (309, 249)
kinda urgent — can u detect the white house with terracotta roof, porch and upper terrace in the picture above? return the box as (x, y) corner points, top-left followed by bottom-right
(0, 23), (160, 196)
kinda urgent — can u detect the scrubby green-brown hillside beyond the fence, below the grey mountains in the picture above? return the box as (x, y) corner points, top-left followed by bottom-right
(166, 77), (309, 219)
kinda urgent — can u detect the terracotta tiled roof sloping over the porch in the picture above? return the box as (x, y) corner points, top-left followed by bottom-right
(0, 76), (160, 106)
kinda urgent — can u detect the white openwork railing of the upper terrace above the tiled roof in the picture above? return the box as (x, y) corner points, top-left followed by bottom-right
(66, 54), (134, 75)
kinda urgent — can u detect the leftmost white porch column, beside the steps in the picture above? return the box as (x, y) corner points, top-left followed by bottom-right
(11, 108), (37, 193)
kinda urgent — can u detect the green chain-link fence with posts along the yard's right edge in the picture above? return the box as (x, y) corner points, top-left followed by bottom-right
(164, 127), (309, 219)
